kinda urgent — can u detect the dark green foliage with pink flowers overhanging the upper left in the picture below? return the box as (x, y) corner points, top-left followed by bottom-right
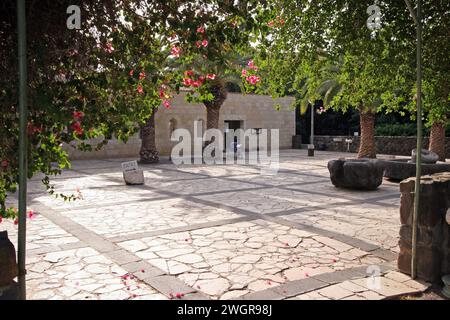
(0, 0), (255, 217)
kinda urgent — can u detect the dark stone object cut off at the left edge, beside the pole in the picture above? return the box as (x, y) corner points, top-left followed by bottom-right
(0, 231), (18, 299)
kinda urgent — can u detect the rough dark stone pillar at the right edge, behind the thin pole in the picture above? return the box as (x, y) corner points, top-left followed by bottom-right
(398, 172), (450, 282)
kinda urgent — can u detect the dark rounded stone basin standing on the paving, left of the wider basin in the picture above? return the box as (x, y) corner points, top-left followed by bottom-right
(328, 159), (384, 190)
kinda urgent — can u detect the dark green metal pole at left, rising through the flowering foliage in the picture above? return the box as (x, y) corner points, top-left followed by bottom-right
(17, 0), (28, 300)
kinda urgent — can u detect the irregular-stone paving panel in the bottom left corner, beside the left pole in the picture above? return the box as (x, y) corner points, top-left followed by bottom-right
(27, 248), (166, 300)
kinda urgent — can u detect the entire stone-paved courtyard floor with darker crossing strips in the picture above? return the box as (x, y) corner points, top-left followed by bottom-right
(2, 150), (427, 300)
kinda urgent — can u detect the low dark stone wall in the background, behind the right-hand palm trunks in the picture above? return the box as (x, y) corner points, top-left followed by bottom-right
(292, 136), (450, 158)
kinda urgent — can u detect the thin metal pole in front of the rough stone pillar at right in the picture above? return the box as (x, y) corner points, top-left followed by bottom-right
(411, 0), (422, 279)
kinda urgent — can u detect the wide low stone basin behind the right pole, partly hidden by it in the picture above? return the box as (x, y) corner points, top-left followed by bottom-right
(382, 159), (450, 181)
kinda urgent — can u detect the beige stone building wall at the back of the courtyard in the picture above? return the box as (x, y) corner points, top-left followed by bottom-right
(65, 93), (295, 159)
